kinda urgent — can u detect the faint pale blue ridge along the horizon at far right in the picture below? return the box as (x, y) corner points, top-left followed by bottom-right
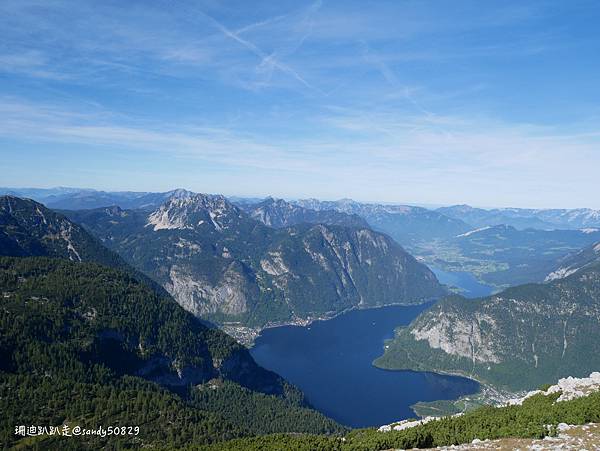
(436, 205), (600, 230)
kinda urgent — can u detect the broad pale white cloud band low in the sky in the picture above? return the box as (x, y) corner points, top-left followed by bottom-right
(0, 97), (600, 206)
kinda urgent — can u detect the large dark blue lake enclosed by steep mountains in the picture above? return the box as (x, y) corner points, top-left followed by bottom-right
(250, 304), (479, 427)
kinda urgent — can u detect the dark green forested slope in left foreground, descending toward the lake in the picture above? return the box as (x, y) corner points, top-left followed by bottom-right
(0, 257), (341, 449)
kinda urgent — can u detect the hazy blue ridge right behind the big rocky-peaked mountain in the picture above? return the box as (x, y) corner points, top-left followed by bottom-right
(293, 199), (472, 246)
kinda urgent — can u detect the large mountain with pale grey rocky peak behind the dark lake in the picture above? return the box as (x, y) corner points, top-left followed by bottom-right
(68, 193), (444, 327)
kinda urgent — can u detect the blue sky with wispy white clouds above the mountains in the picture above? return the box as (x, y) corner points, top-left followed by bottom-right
(0, 0), (600, 208)
